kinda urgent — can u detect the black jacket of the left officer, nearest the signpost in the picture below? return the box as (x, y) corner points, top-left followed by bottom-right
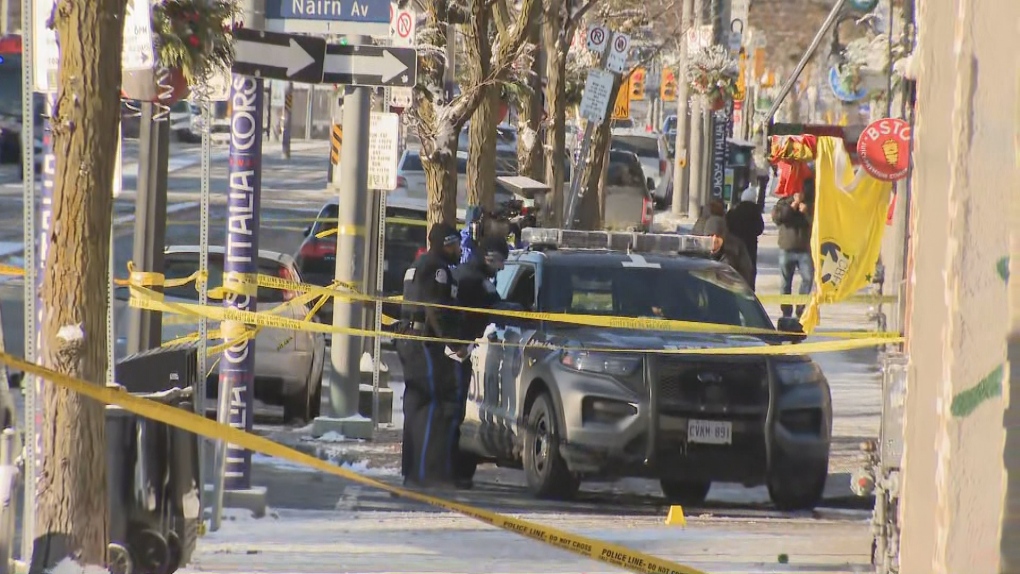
(400, 251), (461, 346)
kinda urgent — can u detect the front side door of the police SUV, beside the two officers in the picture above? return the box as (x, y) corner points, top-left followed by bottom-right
(461, 262), (519, 456)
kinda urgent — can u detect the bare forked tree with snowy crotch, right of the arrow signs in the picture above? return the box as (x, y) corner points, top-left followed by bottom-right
(411, 0), (539, 226)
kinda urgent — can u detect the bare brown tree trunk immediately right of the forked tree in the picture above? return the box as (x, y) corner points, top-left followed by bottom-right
(467, 86), (500, 212)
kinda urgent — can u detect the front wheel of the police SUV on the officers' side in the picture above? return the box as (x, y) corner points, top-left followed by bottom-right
(523, 394), (580, 499)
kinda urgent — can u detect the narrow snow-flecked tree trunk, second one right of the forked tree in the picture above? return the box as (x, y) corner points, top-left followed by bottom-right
(517, 11), (548, 181)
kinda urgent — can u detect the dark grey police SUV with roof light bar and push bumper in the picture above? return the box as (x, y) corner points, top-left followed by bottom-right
(460, 228), (832, 510)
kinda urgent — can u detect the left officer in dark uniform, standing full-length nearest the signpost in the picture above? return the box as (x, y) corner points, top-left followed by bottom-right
(397, 223), (467, 486)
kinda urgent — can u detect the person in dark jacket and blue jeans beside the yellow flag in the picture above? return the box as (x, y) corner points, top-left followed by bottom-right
(772, 186), (815, 319)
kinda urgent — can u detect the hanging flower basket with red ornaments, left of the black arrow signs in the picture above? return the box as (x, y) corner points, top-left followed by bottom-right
(152, 0), (238, 86)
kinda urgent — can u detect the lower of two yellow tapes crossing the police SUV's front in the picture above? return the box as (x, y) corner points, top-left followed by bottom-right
(130, 288), (904, 355)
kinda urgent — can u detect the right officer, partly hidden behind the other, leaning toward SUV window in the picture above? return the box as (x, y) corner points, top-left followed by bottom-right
(450, 236), (510, 488)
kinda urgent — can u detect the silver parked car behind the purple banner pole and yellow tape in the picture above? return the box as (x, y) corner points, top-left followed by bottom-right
(115, 246), (325, 422)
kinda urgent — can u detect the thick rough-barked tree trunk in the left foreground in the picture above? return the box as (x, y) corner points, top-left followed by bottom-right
(30, 0), (124, 572)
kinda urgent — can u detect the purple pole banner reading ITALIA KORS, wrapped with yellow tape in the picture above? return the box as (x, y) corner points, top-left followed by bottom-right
(219, 75), (264, 490)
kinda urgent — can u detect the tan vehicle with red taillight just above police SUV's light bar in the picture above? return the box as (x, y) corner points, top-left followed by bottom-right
(603, 150), (654, 231)
